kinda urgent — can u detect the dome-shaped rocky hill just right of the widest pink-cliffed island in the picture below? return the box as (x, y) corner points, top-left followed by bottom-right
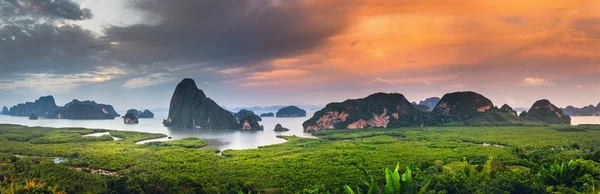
(432, 92), (494, 120)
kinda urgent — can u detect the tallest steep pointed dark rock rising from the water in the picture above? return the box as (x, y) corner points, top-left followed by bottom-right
(163, 78), (240, 130)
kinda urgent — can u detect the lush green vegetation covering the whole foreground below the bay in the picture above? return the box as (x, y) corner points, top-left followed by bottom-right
(0, 125), (600, 193)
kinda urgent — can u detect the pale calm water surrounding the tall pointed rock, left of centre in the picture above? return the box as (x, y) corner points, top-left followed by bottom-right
(0, 112), (312, 150)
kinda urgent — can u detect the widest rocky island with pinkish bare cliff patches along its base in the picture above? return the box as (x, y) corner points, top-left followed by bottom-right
(302, 93), (431, 131)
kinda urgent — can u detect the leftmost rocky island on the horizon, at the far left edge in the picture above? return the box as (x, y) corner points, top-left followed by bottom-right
(9, 96), (58, 117)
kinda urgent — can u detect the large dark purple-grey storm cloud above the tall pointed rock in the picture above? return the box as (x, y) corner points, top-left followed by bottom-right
(105, 0), (346, 66)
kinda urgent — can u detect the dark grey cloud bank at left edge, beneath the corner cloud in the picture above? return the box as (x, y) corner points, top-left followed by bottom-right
(0, 21), (107, 73)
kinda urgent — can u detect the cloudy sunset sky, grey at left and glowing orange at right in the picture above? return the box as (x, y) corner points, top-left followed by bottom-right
(0, 0), (600, 110)
